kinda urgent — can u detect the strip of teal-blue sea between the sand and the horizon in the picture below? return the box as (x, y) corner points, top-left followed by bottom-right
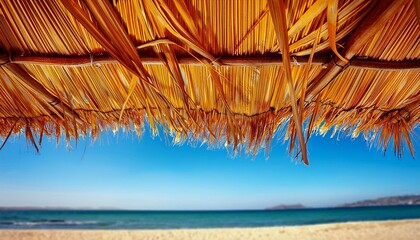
(0, 206), (420, 229)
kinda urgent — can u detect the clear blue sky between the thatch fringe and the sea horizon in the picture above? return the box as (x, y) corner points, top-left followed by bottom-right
(0, 127), (420, 210)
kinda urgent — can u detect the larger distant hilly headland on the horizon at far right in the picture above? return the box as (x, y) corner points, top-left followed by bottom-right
(336, 195), (420, 207)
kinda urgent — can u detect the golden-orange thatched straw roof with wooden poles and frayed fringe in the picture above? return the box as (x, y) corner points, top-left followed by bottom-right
(0, 0), (420, 163)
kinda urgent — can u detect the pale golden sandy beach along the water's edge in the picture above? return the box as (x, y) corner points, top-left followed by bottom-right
(0, 219), (420, 240)
